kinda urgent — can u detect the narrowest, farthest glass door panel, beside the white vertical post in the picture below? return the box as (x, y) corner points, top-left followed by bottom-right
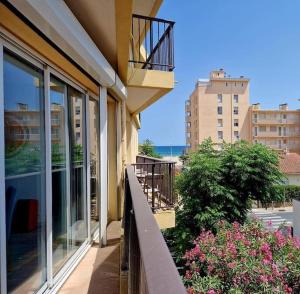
(89, 98), (100, 234)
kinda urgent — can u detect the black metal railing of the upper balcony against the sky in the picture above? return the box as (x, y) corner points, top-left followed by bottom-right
(129, 14), (175, 71)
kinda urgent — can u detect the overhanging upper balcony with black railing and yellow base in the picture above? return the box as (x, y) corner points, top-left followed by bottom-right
(127, 14), (175, 114)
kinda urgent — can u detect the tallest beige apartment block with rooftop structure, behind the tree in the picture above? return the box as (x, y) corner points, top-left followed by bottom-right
(185, 69), (250, 152)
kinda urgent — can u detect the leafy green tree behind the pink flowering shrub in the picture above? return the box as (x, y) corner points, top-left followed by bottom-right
(167, 139), (283, 256)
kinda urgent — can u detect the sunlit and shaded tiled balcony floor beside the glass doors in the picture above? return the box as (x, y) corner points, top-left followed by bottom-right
(59, 222), (121, 294)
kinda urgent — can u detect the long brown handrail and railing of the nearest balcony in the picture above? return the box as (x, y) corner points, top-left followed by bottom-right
(122, 166), (186, 294)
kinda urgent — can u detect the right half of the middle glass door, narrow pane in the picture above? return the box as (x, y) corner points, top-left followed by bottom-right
(68, 87), (87, 251)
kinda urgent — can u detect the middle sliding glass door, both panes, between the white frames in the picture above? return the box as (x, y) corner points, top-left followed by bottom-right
(50, 76), (87, 274)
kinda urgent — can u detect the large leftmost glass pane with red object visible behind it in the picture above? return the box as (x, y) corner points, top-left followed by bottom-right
(4, 52), (46, 293)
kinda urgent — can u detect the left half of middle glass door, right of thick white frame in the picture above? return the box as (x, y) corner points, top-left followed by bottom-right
(50, 76), (68, 274)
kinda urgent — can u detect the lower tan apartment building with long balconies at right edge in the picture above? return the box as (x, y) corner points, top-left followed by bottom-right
(250, 103), (300, 153)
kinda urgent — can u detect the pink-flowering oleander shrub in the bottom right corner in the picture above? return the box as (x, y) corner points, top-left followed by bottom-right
(184, 220), (300, 294)
